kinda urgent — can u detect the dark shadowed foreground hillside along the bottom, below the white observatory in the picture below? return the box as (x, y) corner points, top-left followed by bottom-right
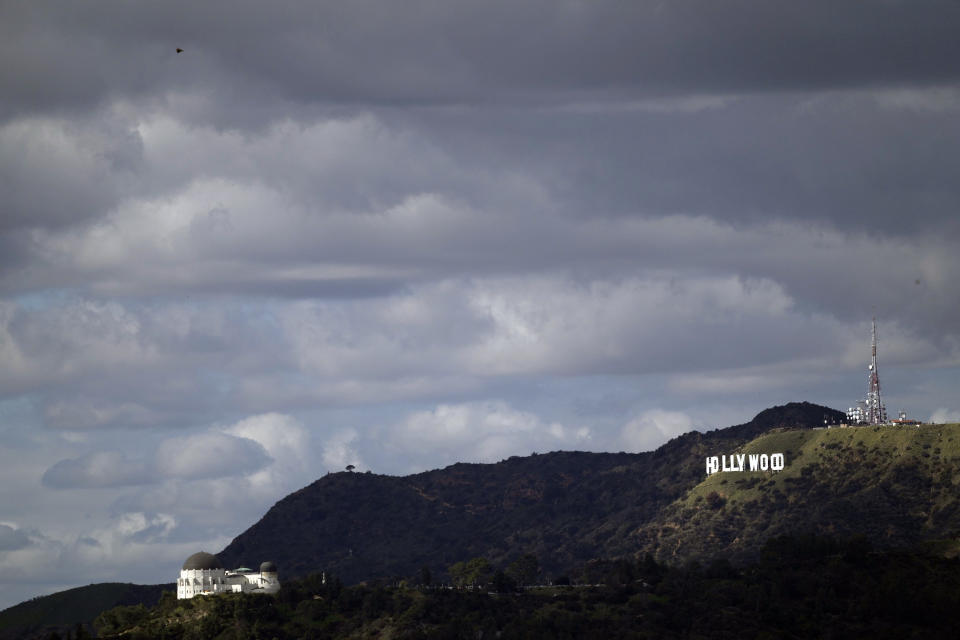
(95, 536), (960, 640)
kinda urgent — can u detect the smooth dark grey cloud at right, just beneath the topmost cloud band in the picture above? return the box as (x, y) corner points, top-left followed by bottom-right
(396, 91), (960, 234)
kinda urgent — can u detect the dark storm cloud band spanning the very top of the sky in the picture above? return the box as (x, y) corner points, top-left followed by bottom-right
(0, 0), (960, 122)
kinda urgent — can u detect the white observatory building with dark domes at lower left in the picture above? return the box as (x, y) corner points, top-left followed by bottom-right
(177, 551), (280, 600)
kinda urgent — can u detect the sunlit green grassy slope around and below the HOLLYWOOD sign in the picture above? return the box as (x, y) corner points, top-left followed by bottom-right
(633, 424), (960, 560)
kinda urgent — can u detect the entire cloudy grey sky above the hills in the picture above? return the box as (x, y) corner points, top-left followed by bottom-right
(0, 0), (960, 607)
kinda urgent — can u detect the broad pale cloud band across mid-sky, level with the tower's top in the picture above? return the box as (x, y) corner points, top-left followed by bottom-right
(11, 270), (960, 429)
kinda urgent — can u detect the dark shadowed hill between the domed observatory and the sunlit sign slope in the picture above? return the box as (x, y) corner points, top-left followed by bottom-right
(218, 403), (842, 582)
